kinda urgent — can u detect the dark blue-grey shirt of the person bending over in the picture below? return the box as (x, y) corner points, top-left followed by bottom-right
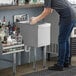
(44, 0), (76, 19)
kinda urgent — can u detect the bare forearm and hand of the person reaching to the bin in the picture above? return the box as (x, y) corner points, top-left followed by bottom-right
(30, 8), (53, 24)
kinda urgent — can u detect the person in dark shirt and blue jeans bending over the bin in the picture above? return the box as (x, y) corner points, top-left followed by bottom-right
(30, 0), (76, 71)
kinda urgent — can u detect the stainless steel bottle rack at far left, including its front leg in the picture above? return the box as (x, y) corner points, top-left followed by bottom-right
(0, 42), (24, 76)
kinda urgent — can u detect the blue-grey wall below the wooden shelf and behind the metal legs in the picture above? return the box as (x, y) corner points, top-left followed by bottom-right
(0, 8), (43, 69)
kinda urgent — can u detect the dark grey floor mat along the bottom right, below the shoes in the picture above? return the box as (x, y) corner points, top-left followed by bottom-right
(22, 66), (76, 76)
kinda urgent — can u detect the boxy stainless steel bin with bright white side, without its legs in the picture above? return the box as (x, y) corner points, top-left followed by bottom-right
(17, 21), (51, 47)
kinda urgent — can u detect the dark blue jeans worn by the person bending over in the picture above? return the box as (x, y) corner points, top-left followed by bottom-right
(58, 17), (75, 66)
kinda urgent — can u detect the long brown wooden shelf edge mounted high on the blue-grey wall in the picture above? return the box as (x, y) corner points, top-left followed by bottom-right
(0, 4), (43, 10)
